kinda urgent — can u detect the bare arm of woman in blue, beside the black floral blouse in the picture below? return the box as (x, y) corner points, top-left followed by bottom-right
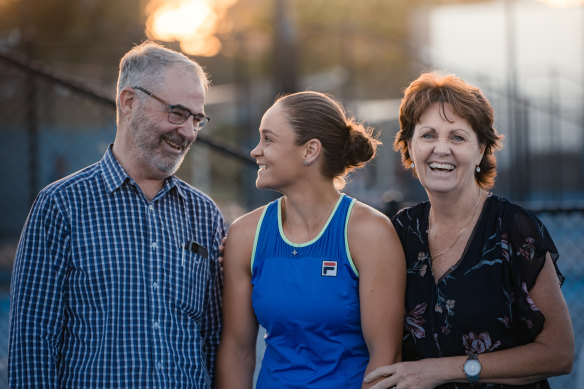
(348, 203), (406, 388)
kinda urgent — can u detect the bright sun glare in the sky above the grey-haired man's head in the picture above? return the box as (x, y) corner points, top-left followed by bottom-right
(146, 0), (237, 57)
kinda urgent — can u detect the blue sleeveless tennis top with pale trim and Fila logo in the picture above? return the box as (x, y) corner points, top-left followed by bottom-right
(252, 194), (369, 389)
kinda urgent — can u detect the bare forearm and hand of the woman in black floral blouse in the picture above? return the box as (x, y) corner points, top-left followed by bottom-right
(367, 255), (574, 389)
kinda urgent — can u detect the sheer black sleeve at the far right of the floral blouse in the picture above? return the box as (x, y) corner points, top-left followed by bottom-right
(508, 208), (564, 342)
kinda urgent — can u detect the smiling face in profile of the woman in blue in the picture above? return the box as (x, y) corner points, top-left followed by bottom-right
(251, 103), (304, 192)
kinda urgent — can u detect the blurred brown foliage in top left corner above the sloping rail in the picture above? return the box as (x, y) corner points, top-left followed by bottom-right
(0, 0), (145, 92)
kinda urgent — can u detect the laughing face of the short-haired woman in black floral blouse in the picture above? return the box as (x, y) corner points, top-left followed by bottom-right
(408, 103), (484, 193)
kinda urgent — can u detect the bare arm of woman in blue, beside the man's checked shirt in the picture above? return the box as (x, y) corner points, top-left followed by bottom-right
(217, 210), (259, 389)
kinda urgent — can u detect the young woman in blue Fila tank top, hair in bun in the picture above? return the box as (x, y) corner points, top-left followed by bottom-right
(217, 92), (406, 389)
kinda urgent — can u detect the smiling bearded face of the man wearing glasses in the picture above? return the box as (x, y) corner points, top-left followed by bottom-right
(128, 66), (205, 179)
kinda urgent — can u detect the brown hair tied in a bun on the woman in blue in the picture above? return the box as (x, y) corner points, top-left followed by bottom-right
(274, 91), (381, 188)
